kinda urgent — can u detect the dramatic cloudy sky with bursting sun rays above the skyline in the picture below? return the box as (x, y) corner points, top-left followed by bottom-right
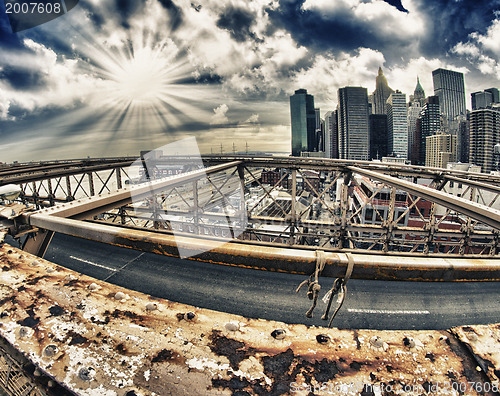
(0, 0), (500, 162)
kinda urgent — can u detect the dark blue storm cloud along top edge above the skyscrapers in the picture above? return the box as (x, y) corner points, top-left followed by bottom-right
(268, 0), (500, 60)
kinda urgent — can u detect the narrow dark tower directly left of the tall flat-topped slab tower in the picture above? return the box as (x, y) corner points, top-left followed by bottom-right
(414, 96), (441, 165)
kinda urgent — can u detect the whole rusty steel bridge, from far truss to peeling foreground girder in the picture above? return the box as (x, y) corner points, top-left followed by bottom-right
(0, 155), (500, 395)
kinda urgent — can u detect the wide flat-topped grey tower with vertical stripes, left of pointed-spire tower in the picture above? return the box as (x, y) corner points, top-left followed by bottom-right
(337, 87), (370, 161)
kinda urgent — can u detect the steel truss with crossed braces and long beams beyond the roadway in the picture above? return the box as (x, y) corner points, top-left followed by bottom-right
(0, 156), (500, 280)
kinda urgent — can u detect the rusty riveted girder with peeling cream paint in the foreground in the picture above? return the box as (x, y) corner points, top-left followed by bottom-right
(0, 240), (500, 396)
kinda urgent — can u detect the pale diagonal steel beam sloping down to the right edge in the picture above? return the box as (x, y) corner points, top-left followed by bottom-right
(348, 166), (500, 230)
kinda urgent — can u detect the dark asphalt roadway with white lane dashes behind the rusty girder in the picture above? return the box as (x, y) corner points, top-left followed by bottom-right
(39, 234), (500, 330)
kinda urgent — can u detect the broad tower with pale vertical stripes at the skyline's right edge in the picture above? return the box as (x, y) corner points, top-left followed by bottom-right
(469, 109), (500, 173)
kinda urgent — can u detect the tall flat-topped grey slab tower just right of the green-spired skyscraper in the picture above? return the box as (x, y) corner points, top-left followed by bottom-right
(432, 69), (466, 127)
